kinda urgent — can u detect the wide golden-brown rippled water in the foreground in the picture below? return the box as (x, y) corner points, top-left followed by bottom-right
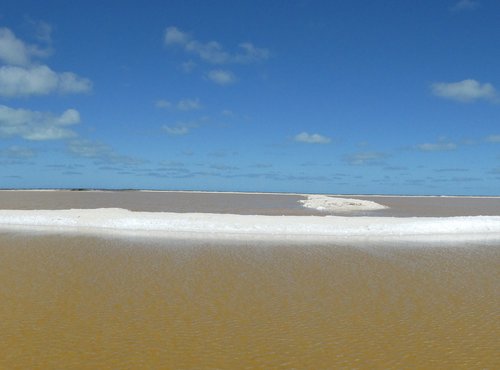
(0, 232), (500, 369)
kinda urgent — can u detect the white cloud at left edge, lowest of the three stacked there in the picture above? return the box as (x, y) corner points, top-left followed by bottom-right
(0, 105), (80, 141)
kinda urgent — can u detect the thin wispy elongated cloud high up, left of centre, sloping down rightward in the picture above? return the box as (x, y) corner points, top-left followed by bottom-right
(165, 27), (269, 64)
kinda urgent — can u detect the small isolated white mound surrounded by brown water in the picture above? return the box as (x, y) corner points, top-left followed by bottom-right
(299, 195), (388, 212)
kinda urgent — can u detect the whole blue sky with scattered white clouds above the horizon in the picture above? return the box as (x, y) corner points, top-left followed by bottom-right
(0, 0), (500, 195)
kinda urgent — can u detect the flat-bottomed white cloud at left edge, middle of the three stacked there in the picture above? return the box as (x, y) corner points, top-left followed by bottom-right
(0, 65), (92, 97)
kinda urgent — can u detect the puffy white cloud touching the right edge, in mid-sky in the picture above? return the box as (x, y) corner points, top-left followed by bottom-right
(431, 79), (497, 102)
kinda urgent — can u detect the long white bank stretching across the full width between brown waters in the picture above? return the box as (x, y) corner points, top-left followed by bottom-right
(0, 208), (500, 241)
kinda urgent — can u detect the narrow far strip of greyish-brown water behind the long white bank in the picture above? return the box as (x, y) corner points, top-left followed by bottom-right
(0, 190), (500, 217)
